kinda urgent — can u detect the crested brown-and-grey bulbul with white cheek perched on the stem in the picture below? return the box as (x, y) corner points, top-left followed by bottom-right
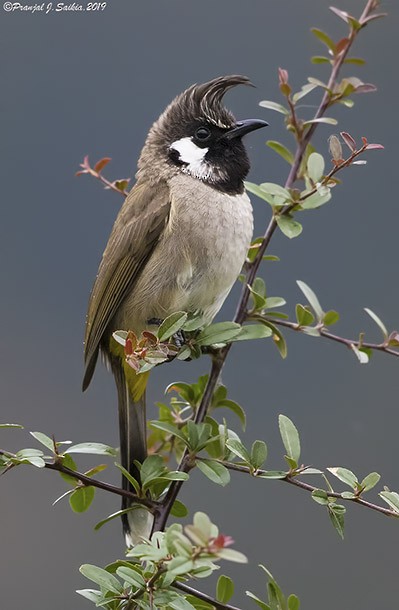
(83, 75), (267, 545)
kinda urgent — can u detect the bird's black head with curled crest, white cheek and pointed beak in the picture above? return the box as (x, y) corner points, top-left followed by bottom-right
(139, 75), (267, 194)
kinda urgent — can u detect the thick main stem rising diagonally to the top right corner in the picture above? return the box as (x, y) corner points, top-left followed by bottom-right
(153, 0), (382, 531)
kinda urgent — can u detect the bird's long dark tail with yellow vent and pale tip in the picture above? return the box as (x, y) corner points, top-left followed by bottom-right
(111, 357), (154, 547)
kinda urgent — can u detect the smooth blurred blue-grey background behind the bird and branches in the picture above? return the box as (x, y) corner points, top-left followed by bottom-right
(0, 0), (399, 610)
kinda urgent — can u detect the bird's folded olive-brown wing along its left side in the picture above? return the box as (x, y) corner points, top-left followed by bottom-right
(83, 182), (170, 389)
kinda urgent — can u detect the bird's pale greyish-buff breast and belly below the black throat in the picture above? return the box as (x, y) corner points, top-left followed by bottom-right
(115, 178), (253, 332)
